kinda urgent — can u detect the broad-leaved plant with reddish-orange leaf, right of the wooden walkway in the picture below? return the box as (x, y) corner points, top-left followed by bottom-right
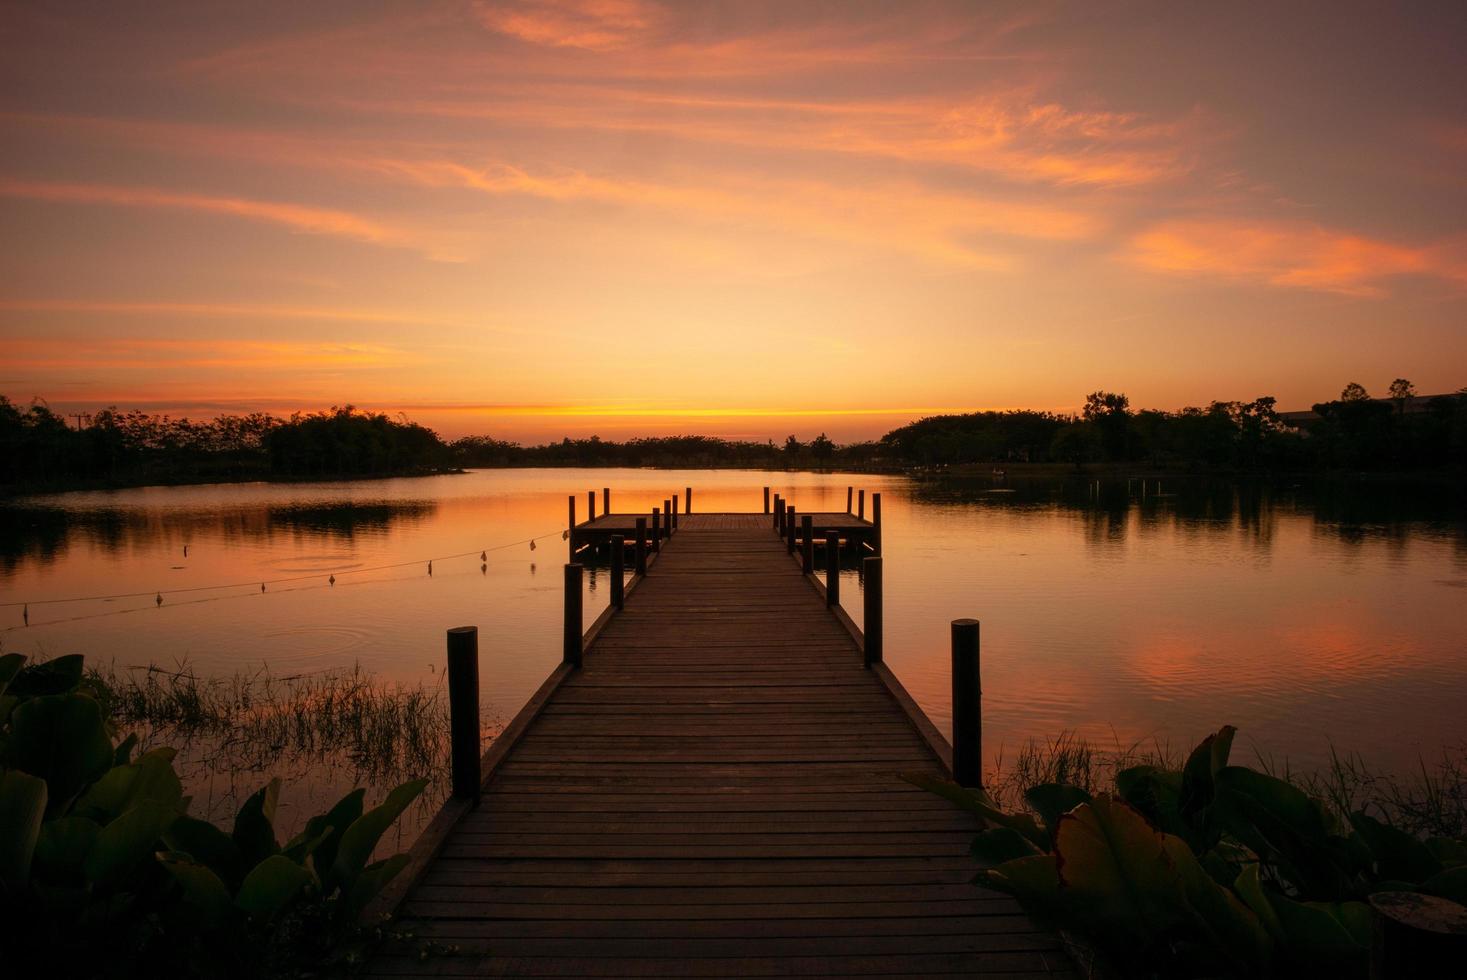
(908, 726), (1467, 977)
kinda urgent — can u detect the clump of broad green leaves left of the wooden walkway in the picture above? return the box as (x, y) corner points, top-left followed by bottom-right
(0, 654), (427, 977)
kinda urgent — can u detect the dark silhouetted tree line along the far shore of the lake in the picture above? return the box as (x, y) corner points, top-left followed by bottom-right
(0, 379), (1467, 490)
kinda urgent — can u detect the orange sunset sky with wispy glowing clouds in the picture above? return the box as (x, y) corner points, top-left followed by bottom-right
(0, 0), (1467, 442)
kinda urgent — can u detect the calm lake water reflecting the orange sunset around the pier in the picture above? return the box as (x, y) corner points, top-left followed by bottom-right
(0, 469), (1467, 839)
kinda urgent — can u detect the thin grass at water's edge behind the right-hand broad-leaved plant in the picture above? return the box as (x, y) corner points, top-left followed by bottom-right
(984, 731), (1467, 838)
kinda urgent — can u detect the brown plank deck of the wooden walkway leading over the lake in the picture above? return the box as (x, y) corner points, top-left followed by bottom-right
(365, 513), (1077, 980)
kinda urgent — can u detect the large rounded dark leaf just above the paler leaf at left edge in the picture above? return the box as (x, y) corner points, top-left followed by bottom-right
(6, 689), (113, 814)
